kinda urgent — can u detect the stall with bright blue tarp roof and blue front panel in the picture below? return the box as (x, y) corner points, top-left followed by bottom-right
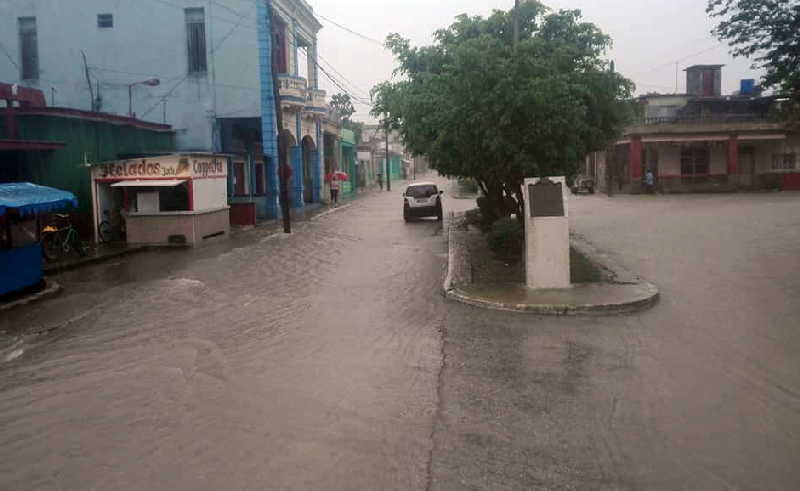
(0, 182), (78, 295)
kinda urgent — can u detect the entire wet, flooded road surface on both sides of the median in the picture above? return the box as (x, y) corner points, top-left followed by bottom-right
(0, 185), (800, 490)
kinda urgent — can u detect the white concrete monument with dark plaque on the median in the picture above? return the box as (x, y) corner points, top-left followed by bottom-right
(522, 177), (571, 288)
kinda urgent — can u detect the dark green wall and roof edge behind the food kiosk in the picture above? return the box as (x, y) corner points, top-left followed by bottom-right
(0, 115), (175, 216)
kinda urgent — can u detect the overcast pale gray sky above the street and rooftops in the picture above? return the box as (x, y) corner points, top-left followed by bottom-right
(307, 0), (760, 120)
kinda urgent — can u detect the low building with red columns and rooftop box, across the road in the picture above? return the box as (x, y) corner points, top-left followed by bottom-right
(584, 65), (800, 193)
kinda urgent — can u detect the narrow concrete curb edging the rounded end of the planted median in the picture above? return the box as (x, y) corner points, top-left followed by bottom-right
(442, 214), (660, 316)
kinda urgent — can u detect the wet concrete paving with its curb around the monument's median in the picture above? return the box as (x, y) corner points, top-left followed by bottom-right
(443, 216), (659, 315)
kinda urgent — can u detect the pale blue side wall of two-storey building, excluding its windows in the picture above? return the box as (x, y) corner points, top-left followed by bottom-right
(0, 0), (261, 151)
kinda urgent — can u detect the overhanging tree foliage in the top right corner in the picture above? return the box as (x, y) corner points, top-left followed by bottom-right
(706, 0), (800, 119)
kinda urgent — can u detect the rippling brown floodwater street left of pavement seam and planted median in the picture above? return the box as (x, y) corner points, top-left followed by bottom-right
(0, 185), (446, 489)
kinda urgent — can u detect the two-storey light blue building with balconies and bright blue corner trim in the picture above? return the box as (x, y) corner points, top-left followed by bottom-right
(0, 0), (326, 223)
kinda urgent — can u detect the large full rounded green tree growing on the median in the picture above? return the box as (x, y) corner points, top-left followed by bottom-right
(371, 1), (632, 219)
